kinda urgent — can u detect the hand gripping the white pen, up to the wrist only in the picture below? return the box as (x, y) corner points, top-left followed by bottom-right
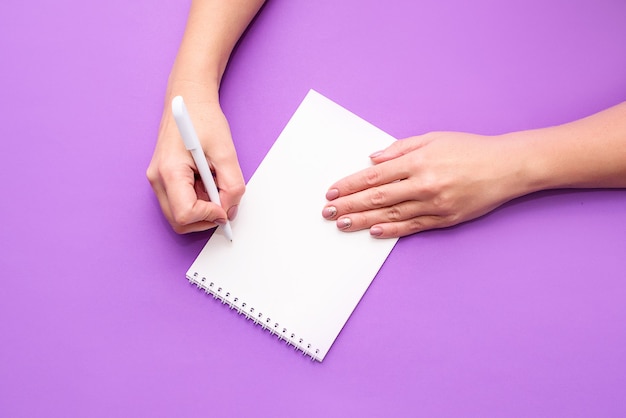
(146, 81), (245, 234)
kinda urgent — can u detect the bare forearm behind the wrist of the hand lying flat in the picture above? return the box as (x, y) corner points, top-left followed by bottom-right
(506, 102), (626, 193)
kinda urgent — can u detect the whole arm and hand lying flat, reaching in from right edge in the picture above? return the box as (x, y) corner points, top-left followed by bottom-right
(322, 102), (626, 238)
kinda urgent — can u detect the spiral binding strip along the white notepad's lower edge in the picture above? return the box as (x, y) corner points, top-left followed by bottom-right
(187, 272), (321, 361)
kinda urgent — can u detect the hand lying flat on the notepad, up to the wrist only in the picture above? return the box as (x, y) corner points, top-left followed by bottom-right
(322, 132), (528, 238)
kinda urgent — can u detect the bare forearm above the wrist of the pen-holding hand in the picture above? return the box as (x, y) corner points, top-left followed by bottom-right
(169, 0), (264, 93)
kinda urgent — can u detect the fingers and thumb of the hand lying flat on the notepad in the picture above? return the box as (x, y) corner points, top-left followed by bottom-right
(322, 135), (458, 238)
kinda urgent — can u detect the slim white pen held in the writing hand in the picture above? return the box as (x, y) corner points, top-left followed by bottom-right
(172, 96), (233, 241)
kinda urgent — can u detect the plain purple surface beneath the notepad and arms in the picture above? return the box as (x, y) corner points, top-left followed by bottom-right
(0, 0), (626, 417)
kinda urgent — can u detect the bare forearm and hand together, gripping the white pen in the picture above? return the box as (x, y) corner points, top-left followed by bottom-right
(146, 0), (263, 233)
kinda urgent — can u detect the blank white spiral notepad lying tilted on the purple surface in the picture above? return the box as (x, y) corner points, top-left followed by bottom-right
(187, 90), (397, 361)
